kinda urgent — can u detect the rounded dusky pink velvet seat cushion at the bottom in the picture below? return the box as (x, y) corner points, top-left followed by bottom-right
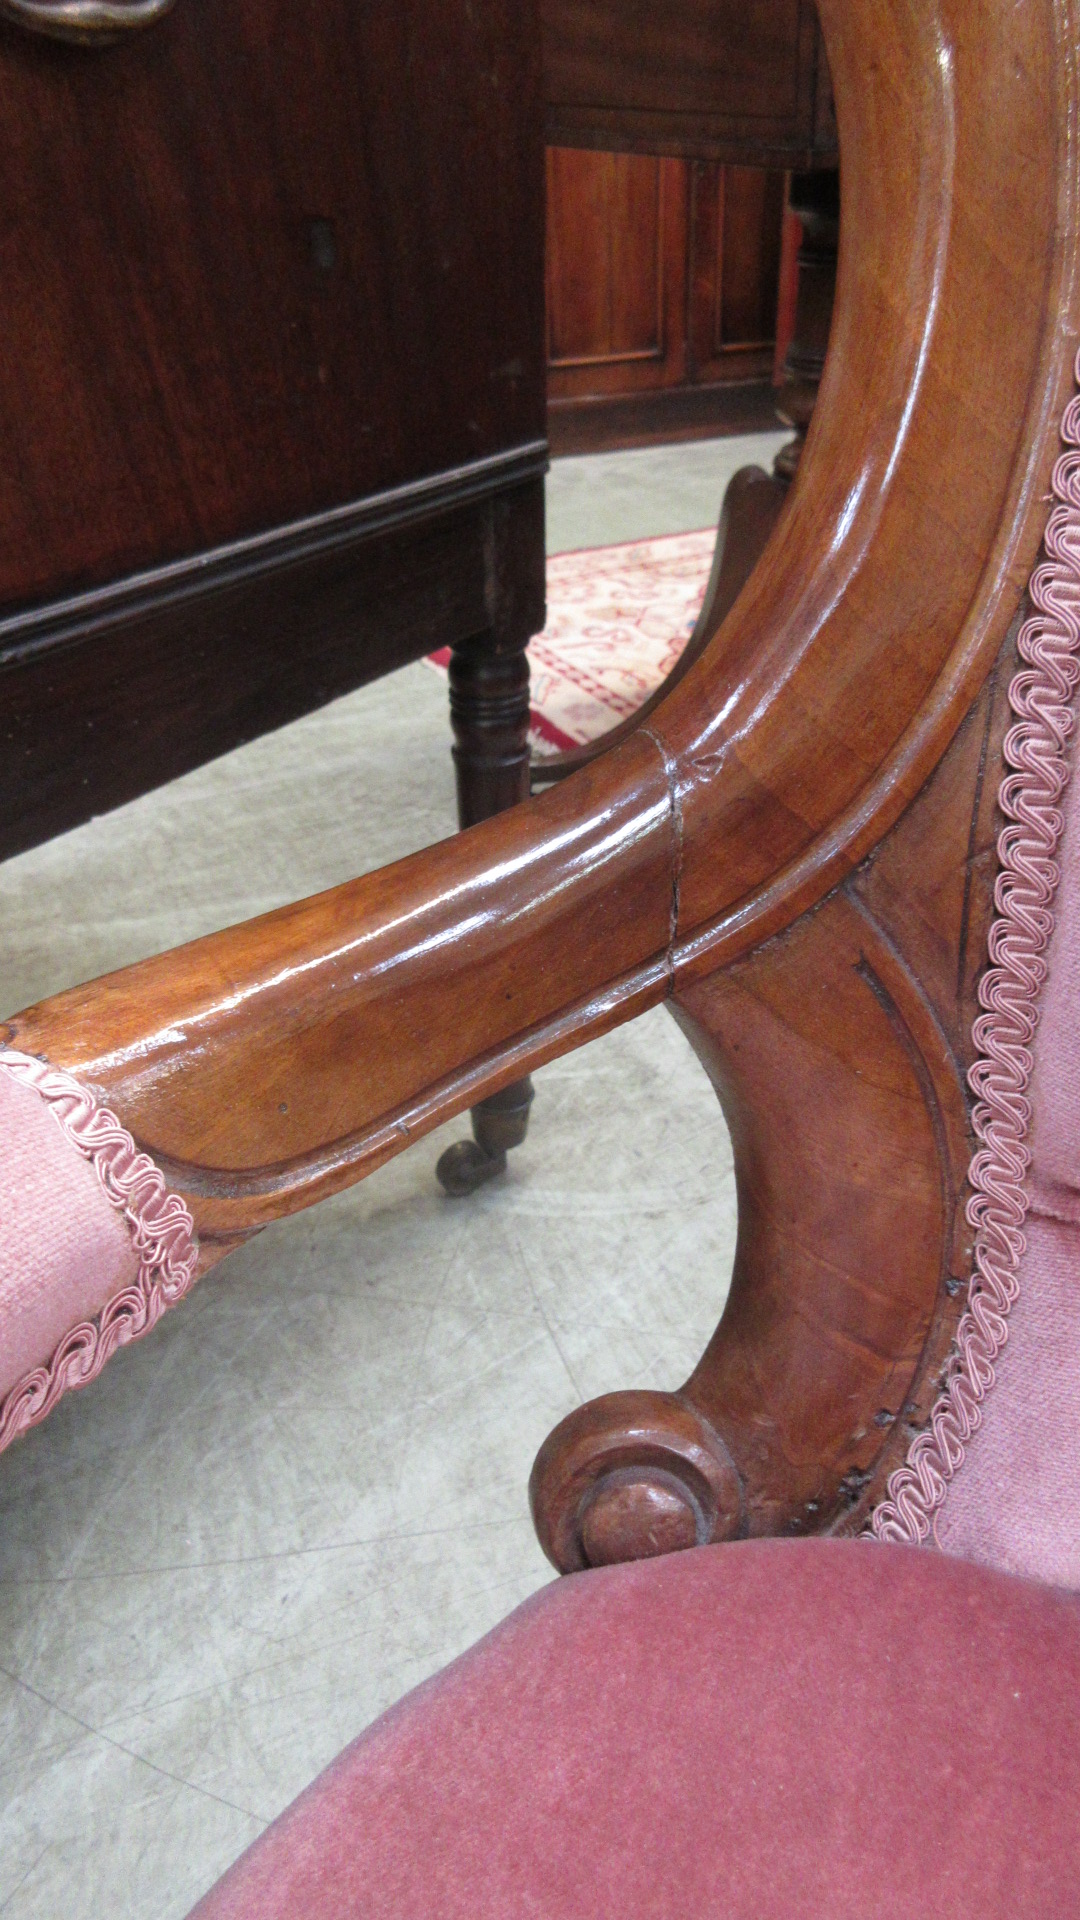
(184, 1540), (1080, 1920)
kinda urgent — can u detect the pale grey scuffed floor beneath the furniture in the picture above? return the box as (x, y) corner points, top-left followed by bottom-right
(0, 436), (780, 1920)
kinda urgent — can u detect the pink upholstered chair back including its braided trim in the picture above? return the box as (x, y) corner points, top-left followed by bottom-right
(872, 424), (1080, 1588)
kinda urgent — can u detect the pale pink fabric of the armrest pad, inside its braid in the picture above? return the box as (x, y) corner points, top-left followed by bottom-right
(0, 1071), (138, 1404)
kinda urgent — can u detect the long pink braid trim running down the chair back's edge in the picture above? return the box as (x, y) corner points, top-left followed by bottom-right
(871, 355), (1080, 1544)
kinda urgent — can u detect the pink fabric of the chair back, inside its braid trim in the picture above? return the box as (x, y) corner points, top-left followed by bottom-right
(936, 756), (1080, 1588)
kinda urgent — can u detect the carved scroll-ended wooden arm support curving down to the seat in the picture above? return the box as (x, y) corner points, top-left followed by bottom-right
(532, 639), (1013, 1571)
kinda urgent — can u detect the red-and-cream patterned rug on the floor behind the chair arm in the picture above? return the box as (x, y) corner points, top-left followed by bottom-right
(429, 526), (717, 755)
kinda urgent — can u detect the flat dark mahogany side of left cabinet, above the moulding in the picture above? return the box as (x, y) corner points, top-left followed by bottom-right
(0, 0), (542, 607)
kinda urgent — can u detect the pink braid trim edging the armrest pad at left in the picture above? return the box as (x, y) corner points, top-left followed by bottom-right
(0, 1046), (198, 1453)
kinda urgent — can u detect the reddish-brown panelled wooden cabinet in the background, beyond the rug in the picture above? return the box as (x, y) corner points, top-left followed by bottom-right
(546, 146), (784, 453)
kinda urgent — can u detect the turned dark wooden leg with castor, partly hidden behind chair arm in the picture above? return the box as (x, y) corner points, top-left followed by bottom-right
(436, 630), (532, 1198)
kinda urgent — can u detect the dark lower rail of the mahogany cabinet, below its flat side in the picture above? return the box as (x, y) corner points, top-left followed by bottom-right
(0, 456), (548, 858)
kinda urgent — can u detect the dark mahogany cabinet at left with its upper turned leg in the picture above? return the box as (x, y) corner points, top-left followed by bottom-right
(0, 0), (546, 856)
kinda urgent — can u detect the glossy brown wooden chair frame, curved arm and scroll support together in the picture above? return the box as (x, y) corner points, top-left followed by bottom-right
(6, 0), (1080, 1565)
